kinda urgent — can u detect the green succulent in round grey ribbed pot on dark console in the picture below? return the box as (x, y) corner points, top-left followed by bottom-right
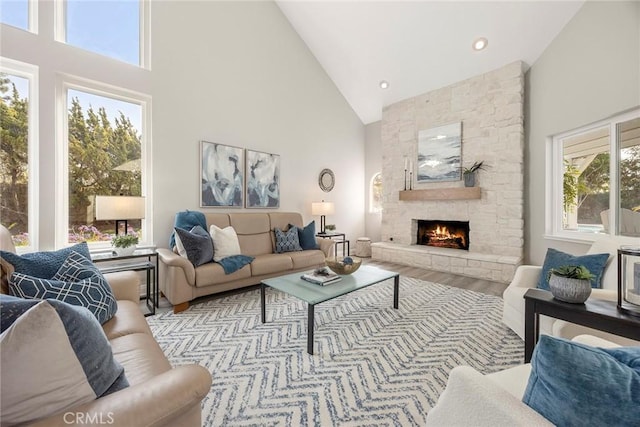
(548, 265), (595, 304)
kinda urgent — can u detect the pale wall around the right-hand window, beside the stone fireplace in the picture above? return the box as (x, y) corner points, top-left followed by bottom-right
(525, 2), (640, 264)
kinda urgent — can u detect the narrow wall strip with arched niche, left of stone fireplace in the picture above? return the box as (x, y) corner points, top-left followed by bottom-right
(364, 121), (382, 242)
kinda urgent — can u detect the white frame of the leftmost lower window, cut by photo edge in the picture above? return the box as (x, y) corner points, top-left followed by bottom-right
(0, 57), (40, 253)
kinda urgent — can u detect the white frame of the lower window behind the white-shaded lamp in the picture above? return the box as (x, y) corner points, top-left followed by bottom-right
(55, 74), (153, 251)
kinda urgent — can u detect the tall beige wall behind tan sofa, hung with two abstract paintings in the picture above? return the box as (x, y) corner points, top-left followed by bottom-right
(151, 1), (365, 247)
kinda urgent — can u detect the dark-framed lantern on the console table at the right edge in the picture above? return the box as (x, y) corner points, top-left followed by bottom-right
(618, 246), (640, 316)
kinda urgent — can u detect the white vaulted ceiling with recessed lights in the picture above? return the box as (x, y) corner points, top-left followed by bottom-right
(277, 0), (584, 124)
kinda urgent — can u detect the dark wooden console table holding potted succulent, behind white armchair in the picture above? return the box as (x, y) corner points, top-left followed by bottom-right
(524, 289), (640, 363)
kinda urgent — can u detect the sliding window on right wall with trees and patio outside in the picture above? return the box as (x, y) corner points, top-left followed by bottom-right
(547, 110), (640, 238)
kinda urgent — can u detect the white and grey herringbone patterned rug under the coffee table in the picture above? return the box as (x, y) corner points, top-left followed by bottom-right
(147, 277), (524, 426)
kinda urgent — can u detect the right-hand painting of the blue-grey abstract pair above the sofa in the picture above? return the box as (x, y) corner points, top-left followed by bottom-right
(245, 150), (280, 208)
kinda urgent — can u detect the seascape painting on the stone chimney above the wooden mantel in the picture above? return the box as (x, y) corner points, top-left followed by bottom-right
(416, 122), (462, 182)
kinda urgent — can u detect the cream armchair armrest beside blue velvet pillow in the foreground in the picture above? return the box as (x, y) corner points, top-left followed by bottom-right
(427, 366), (553, 427)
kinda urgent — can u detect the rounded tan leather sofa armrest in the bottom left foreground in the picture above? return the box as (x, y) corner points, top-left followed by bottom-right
(32, 365), (211, 427)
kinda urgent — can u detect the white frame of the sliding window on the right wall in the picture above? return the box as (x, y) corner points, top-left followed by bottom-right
(544, 107), (640, 243)
